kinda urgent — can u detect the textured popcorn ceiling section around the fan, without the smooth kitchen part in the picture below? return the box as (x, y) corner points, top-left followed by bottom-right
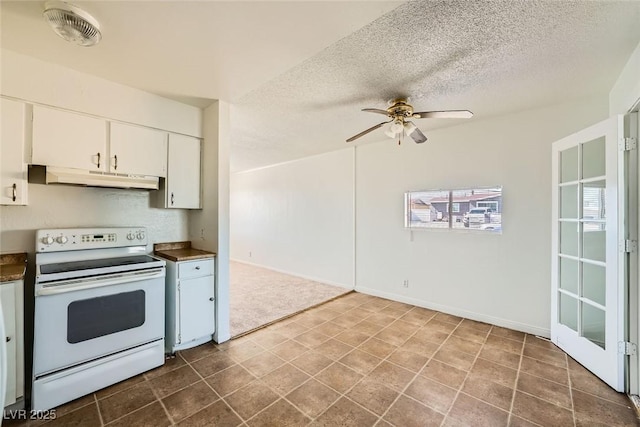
(232, 1), (640, 171)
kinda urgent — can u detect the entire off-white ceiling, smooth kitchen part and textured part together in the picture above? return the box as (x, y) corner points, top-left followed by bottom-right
(0, 0), (640, 171)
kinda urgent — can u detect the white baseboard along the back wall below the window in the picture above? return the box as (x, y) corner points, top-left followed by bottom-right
(355, 286), (551, 338)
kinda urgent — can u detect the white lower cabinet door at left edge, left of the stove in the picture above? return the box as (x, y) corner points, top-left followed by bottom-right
(0, 282), (18, 407)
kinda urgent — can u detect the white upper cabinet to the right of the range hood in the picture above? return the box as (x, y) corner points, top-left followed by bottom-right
(164, 134), (200, 209)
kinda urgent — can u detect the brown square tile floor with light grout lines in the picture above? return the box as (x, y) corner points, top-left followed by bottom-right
(5, 293), (638, 427)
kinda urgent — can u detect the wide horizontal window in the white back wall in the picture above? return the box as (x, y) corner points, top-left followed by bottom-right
(405, 187), (502, 233)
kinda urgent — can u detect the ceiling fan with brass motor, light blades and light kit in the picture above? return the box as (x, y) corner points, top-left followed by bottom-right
(347, 98), (473, 144)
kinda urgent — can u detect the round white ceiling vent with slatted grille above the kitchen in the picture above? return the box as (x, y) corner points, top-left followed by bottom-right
(43, 1), (102, 47)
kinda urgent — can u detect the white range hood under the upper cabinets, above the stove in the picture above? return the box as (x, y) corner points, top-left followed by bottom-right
(29, 165), (160, 190)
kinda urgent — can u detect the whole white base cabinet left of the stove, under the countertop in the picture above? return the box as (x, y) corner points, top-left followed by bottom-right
(0, 280), (24, 407)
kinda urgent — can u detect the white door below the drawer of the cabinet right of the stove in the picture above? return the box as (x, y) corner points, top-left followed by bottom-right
(178, 276), (214, 344)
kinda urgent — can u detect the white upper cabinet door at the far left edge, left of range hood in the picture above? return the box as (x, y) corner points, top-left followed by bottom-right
(0, 98), (27, 205)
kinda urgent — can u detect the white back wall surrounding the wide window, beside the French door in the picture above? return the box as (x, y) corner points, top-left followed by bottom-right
(356, 97), (608, 336)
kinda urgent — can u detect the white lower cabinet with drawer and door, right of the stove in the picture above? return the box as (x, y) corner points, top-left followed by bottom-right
(165, 258), (215, 353)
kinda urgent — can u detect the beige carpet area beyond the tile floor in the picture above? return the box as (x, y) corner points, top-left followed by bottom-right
(229, 261), (350, 338)
